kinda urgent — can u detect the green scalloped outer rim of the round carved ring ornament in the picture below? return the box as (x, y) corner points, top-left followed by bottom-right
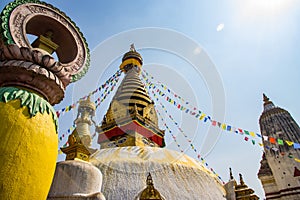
(0, 0), (90, 82)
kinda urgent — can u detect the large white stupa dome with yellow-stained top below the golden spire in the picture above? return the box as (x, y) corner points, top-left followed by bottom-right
(91, 146), (225, 200)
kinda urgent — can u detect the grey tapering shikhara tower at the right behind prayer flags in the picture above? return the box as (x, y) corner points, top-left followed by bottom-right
(258, 95), (300, 200)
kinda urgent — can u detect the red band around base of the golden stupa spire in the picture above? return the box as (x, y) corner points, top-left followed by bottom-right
(98, 120), (164, 147)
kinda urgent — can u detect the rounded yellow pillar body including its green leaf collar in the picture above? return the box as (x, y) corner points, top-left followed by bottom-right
(0, 87), (58, 200)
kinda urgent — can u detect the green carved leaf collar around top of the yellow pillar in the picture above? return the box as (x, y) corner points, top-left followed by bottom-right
(0, 87), (58, 132)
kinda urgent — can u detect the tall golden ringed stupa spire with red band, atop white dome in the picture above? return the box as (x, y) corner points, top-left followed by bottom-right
(97, 45), (165, 148)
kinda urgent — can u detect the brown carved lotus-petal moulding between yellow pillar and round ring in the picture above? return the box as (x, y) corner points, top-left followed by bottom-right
(0, 44), (66, 105)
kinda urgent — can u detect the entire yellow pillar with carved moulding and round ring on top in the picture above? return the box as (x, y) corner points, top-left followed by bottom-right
(0, 0), (89, 199)
